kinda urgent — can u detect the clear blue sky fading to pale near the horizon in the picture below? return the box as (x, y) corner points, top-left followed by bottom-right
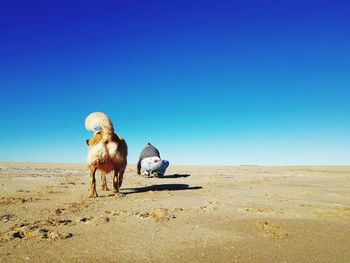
(0, 0), (350, 165)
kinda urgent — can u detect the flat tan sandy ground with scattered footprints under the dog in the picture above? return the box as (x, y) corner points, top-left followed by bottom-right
(0, 163), (350, 262)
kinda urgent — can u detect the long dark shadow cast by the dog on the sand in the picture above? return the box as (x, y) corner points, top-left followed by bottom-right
(122, 184), (203, 195)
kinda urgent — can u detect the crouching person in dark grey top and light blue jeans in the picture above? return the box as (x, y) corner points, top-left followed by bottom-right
(137, 143), (169, 177)
